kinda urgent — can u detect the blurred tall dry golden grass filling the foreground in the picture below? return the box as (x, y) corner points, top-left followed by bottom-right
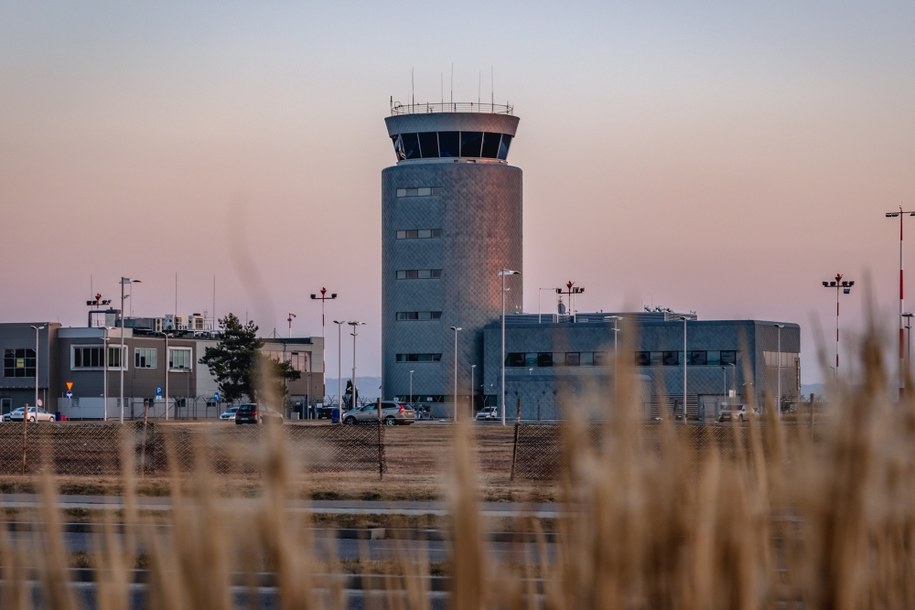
(0, 326), (915, 610)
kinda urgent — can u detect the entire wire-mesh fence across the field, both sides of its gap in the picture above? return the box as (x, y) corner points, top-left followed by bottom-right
(0, 421), (808, 480)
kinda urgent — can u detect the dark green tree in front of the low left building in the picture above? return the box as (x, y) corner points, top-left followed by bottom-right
(200, 313), (300, 407)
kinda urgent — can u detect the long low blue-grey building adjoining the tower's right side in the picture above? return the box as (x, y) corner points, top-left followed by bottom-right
(484, 311), (801, 421)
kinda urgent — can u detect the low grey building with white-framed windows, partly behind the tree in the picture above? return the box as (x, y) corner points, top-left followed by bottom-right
(0, 318), (324, 419)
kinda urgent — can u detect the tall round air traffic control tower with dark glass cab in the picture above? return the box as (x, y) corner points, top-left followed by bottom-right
(381, 102), (522, 418)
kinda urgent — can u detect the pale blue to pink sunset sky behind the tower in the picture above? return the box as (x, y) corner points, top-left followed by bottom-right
(0, 0), (915, 383)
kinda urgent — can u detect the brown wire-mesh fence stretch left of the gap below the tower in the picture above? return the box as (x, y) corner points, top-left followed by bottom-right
(0, 421), (387, 476)
